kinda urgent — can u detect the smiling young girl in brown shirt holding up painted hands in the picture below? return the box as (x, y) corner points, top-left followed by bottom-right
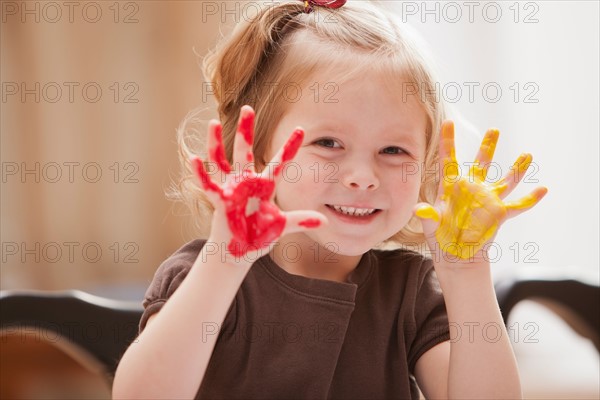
(113, 0), (546, 399)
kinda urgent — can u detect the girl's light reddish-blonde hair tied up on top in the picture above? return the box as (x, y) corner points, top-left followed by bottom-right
(169, 0), (444, 245)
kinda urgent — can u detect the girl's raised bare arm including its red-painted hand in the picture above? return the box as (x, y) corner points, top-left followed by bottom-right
(113, 106), (327, 399)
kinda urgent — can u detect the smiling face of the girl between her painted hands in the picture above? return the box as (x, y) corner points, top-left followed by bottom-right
(267, 69), (427, 256)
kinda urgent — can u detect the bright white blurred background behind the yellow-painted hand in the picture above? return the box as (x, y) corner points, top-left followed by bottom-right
(392, 1), (600, 276)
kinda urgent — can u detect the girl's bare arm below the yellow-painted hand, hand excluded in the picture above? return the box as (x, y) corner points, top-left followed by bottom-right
(415, 263), (522, 399)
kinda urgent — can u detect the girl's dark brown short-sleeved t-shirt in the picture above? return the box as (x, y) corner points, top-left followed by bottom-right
(140, 240), (449, 400)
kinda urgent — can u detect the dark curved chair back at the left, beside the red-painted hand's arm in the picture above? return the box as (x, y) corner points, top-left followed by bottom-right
(0, 290), (143, 381)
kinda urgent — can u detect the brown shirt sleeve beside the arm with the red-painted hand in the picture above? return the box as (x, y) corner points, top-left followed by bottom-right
(139, 239), (205, 333)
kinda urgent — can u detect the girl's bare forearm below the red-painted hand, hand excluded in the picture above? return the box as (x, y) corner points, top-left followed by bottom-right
(113, 245), (250, 399)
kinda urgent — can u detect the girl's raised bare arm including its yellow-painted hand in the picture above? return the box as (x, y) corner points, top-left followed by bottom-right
(415, 122), (547, 399)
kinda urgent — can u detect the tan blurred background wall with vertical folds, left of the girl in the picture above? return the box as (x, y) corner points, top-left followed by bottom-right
(1, 1), (230, 298)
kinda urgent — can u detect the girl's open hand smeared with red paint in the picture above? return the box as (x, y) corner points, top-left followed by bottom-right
(191, 106), (327, 265)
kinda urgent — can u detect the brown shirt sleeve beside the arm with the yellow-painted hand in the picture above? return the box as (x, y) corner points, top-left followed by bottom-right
(408, 258), (450, 374)
